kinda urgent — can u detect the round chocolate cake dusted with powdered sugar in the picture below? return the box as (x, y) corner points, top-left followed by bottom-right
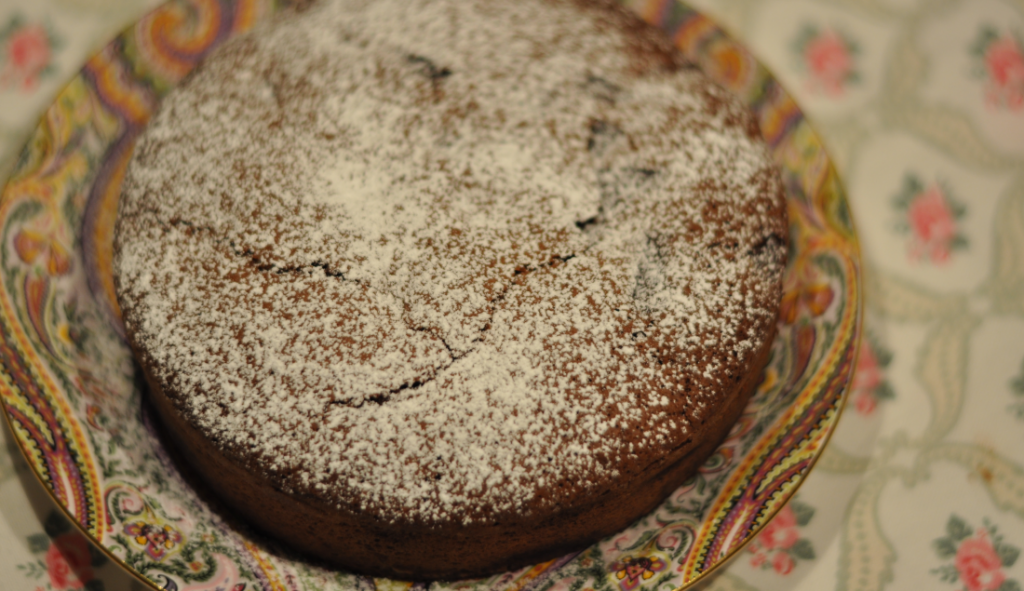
(115, 0), (786, 580)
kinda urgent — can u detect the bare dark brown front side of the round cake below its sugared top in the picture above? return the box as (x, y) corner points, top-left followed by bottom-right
(131, 317), (777, 580)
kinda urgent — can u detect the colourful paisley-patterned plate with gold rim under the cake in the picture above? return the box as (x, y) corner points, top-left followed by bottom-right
(0, 0), (861, 591)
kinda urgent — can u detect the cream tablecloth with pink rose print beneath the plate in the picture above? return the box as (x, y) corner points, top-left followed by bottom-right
(0, 0), (1024, 591)
